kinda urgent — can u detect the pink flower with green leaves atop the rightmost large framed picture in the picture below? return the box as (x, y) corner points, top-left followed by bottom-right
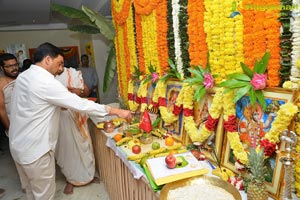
(219, 52), (270, 110)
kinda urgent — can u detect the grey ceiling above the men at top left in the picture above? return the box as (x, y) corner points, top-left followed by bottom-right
(0, 0), (111, 31)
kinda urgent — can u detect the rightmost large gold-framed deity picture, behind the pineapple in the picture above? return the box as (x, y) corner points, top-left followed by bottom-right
(222, 89), (293, 199)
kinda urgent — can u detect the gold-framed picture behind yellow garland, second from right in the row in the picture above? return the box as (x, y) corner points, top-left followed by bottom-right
(184, 89), (224, 164)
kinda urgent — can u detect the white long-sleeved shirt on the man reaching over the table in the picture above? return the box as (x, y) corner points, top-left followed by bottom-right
(9, 65), (108, 164)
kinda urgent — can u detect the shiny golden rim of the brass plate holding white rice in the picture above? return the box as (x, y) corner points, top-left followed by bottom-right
(159, 175), (242, 200)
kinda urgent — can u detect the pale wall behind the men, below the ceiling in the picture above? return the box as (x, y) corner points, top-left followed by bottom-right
(0, 30), (118, 104)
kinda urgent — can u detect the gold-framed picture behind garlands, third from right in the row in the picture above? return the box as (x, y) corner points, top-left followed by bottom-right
(162, 81), (183, 141)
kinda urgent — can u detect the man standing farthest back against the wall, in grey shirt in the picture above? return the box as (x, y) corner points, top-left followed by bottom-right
(78, 54), (99, 101)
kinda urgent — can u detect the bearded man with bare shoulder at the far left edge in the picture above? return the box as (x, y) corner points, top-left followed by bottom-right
(0, 53), (19, 198)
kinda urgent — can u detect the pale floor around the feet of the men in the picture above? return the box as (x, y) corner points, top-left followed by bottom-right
(0, 137), (109, 200)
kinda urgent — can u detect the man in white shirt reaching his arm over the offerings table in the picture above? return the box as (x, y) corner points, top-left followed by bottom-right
(9, 43), (131, 200)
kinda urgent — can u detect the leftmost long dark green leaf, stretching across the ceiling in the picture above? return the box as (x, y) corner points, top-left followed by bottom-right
(51, 3), (95, 26)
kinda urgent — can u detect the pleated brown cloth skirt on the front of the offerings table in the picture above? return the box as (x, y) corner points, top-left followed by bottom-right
(89, 120), (159, 200)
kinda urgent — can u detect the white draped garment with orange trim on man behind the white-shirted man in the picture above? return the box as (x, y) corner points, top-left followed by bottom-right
(55, 68), (95, 185)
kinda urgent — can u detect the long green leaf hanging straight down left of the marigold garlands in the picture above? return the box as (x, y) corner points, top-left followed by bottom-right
(103, 45), (117, 92)
